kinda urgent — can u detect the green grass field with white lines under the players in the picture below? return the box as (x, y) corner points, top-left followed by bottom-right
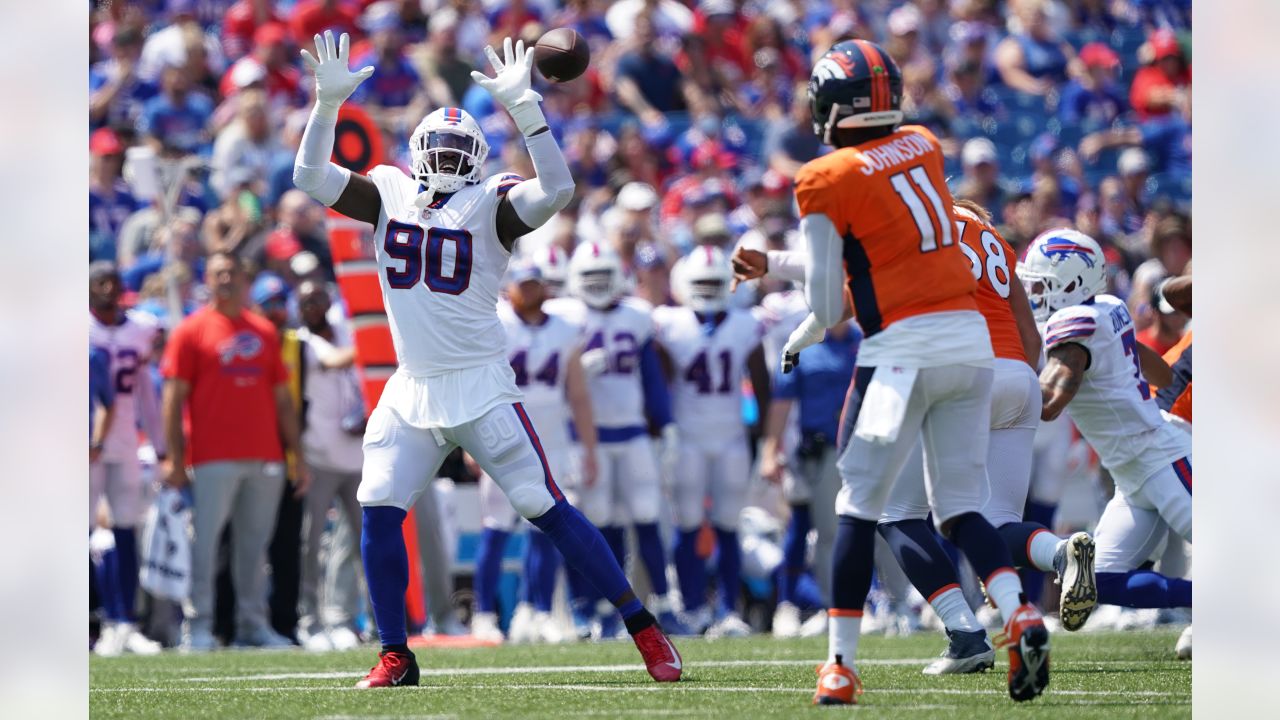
(90, 630), (1192, 720)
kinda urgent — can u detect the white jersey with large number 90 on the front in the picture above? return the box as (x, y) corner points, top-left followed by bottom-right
(369, 165), (521, 377)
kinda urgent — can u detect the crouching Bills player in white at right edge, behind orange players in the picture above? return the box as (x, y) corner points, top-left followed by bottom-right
(1018, 229), (1192, 650)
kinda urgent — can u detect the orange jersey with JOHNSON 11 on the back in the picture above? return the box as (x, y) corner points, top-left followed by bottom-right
(796, 126), (978, 337)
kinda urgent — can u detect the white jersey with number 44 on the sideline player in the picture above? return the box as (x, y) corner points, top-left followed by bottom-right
(498, 302), (581, 447)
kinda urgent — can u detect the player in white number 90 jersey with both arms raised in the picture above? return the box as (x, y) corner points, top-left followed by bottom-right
(293, 32), (681, 688)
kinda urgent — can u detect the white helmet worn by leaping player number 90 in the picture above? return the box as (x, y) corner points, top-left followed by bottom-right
(408, 108), (489, 195)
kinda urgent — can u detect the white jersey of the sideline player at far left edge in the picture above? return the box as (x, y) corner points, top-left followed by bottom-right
(88, 310), (159, 462)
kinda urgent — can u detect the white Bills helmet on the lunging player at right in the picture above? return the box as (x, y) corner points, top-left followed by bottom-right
(1018, 228), (1107, 323)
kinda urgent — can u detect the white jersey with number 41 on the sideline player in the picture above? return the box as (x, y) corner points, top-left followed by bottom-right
(653, 307), (764, 441)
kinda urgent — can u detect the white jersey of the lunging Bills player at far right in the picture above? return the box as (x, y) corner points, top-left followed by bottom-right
(1044, 295), (1190, 492)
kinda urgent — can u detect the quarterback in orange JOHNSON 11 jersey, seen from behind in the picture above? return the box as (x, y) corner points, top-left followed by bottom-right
(737, 40), (1048, 703)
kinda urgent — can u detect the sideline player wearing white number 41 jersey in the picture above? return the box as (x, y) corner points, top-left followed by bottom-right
(653, 245), (769, 637)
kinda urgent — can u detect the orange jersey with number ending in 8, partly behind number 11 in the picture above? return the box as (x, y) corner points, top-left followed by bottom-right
(955, 208), (1027, 363)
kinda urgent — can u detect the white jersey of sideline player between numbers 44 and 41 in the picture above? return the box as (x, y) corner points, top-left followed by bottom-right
(552, 297), (654, 428)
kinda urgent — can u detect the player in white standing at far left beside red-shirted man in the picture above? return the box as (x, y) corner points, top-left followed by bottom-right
(88, 260), (165, 656)
